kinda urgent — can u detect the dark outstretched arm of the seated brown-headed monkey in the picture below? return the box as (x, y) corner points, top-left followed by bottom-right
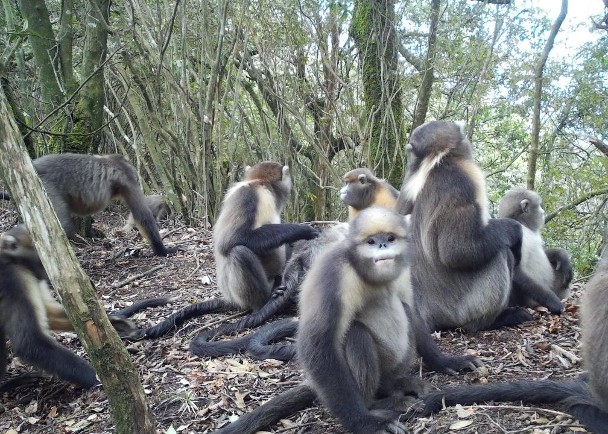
(235, 223), (319, 255)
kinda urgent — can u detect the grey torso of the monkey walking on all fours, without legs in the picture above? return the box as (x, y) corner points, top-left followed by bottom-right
(34, 153), (139, 215)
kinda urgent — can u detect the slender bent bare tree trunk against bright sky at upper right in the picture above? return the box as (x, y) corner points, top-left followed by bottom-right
(526, 0), (568, 190)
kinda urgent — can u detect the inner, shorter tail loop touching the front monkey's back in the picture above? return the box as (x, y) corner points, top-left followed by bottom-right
(247, 318), (298, 361)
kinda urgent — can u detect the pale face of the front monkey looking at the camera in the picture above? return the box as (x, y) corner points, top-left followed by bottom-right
(354, 232), (406, 284)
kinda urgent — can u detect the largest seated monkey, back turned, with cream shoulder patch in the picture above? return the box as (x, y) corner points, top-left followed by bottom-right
(395, 121), (532, 332)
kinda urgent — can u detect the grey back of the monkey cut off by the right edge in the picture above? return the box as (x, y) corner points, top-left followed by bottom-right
(581, 256), (608, 412)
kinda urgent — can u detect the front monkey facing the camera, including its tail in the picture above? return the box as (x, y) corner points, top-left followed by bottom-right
(217, 207), (424, 434)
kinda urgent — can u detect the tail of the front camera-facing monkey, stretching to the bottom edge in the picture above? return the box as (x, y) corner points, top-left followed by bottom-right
(215, 384), (315, 434)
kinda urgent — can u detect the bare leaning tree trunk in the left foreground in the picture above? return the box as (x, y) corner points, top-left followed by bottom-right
(0, 86), (156, 434)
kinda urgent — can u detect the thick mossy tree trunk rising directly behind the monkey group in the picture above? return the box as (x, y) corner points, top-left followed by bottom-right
(350, 0), (404, 186)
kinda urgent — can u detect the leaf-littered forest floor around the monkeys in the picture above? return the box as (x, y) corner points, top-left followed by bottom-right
(0, 202), (585, 434)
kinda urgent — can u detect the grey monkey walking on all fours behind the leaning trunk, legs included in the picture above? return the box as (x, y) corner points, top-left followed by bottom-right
(33, 153), (175, 256)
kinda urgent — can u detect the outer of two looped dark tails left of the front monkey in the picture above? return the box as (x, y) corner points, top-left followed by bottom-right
(190, 287), (297, 357)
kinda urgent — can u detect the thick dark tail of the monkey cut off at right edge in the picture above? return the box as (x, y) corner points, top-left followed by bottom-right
(423, 377), (608, 434)
